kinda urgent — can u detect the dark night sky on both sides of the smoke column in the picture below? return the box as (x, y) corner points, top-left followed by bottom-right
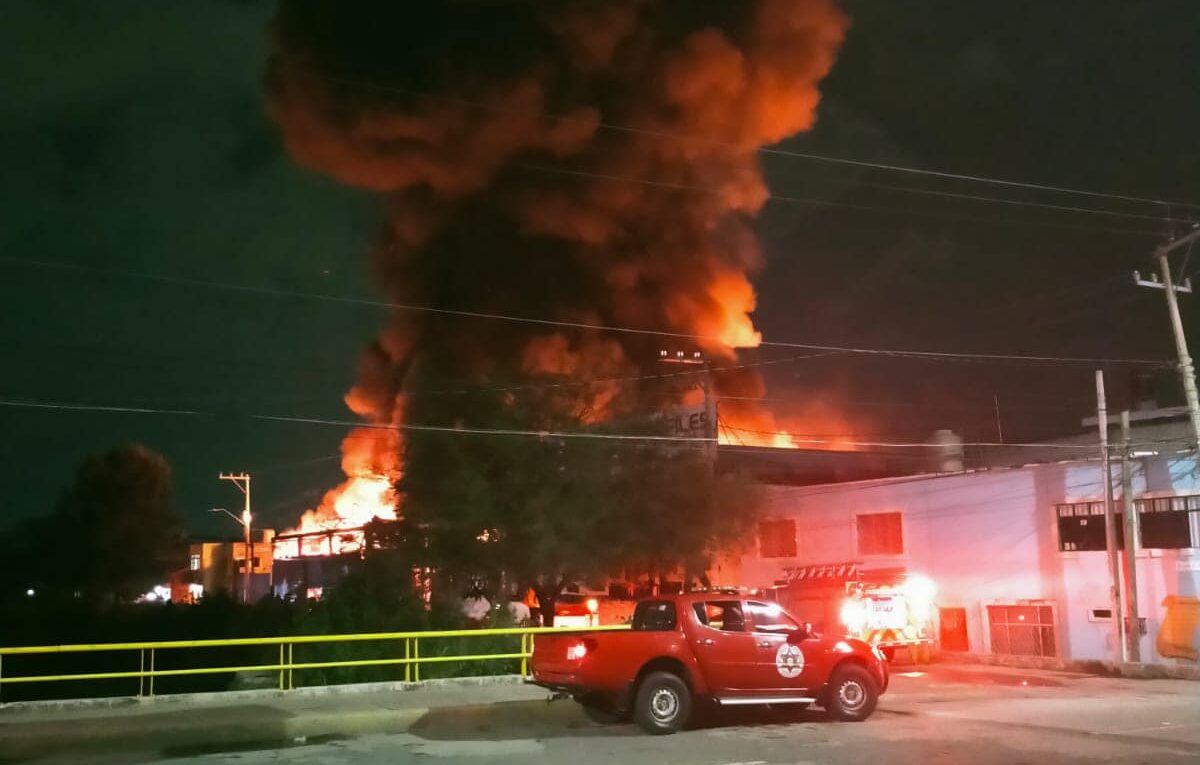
(0, 0), (1200, 534)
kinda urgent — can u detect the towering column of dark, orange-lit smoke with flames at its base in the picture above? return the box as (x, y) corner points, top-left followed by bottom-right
(266, 0), (847, 559)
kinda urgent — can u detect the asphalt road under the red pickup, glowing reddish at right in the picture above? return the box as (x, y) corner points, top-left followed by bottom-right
(18, 665), (1200, 765)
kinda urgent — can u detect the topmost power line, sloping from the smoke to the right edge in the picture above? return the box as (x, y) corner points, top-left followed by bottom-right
(318, 76), (1200, 210)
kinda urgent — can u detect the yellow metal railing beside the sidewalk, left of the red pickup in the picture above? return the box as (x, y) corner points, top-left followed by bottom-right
(0, 625), (629, 695)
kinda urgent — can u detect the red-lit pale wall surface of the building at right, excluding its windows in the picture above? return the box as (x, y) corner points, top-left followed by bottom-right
(722, 459), (1200, 661)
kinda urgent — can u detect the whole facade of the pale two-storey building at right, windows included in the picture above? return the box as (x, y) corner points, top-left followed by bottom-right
(721, 456), (1200, 664)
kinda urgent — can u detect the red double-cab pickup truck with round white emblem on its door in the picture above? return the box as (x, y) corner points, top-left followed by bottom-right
(532, 591), (888, 734)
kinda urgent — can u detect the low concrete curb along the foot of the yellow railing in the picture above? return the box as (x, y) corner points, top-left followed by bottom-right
(0, 675), (524, 719)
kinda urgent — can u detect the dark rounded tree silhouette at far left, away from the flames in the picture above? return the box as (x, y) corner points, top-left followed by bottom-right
(10, 445), (184, 601)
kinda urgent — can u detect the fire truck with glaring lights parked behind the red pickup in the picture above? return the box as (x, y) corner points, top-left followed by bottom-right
(769, 562), (937, 662)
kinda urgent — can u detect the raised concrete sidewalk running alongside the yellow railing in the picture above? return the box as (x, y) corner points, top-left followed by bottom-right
(0, 676), (546, 765)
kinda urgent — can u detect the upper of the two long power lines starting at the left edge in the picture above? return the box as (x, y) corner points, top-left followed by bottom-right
(0, 255), (1174, 367)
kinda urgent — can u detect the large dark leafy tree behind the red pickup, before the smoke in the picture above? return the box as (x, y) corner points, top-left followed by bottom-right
(400, 386), (757, 628)
